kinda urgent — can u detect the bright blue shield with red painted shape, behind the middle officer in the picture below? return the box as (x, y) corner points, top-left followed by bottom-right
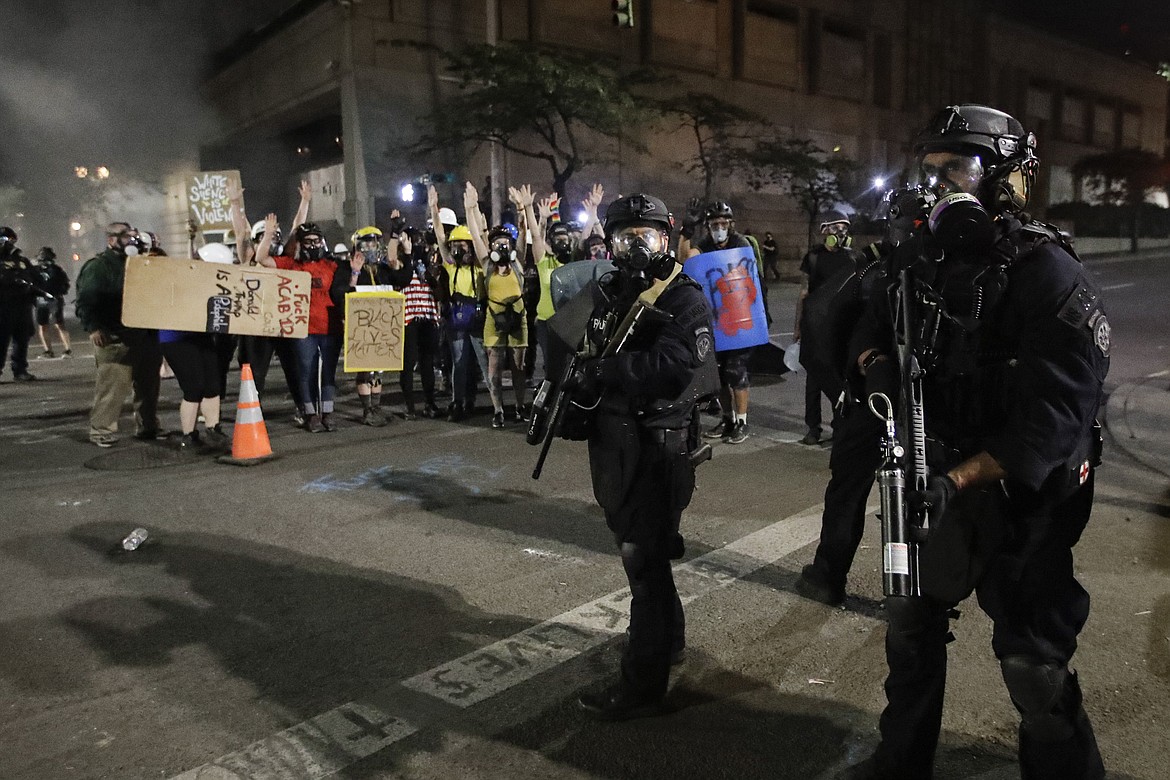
(682, 247), (768, 352)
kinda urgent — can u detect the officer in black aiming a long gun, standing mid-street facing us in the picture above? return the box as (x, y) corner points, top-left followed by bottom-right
(569, 194), (718, 720)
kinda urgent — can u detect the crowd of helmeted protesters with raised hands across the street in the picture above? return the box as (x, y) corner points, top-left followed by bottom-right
(8, 176), (819, 451)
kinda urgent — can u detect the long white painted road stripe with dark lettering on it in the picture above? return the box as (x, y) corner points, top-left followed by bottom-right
(172, 506), (821, 780)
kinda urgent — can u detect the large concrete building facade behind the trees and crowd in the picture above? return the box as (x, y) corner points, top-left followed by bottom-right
(201, 0), (1170, 257)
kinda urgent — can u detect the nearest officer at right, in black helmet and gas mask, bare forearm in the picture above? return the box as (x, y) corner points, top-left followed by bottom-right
(847, 104), (1109, 780)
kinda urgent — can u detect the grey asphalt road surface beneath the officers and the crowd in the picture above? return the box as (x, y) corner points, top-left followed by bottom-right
(0, 256), (1170, 780)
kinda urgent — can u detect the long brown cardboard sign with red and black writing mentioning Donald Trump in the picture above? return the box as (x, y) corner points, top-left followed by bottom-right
(122, 257), (311, 338)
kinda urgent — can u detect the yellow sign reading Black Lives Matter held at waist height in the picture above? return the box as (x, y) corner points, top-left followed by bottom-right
(344, 292), (406, 373)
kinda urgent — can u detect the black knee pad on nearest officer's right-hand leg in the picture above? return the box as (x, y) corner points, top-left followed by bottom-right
(999, 655), (1081, 741)
